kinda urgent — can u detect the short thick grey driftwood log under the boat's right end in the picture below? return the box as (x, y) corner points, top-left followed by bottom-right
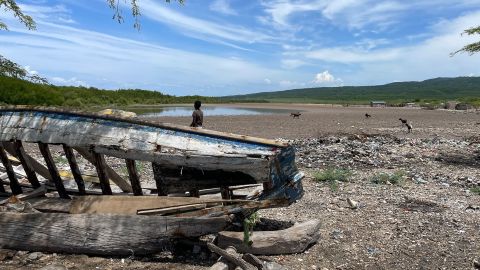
(218, 220), (320, 255)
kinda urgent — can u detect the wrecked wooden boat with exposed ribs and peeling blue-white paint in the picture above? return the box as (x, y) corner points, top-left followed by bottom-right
(0, 106), (303, 255)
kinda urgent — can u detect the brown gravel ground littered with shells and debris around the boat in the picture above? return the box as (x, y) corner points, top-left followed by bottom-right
(0, 105), (480, 269)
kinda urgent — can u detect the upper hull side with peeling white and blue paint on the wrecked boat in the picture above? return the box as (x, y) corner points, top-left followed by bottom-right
(0, 110), (286, 186)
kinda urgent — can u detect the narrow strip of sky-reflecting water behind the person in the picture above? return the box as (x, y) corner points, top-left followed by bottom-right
(129, 106), (289, 117)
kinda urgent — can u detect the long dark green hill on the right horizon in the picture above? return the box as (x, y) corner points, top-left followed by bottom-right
(222, 77), (480, 104)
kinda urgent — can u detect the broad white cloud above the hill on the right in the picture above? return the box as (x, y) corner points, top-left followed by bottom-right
(304, 11), (480, 85)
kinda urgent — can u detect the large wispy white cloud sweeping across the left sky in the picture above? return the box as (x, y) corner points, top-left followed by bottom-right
(0, 19), (285, 95)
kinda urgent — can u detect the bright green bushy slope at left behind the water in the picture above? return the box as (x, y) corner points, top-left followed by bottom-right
(0, 76), (219, 108)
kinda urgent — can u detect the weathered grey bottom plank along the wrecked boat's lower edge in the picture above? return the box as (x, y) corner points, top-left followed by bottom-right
(0, 213), (227, 256)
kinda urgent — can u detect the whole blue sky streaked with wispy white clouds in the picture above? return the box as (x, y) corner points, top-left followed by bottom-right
(0, 0), (480, 96)
